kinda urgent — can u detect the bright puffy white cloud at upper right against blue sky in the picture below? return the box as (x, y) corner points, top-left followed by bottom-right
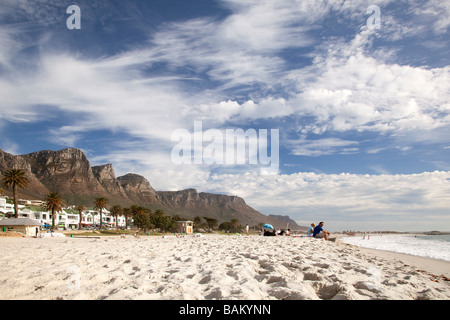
(227, 32), (450, 143)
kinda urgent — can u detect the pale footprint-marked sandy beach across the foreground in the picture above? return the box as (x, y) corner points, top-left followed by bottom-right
(0, 235), (450, 300)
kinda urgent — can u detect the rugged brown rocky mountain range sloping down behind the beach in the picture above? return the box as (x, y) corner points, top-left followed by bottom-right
(0, 148), (300, 229)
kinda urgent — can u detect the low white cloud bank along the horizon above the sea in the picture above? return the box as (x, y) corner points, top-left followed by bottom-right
(199, 171), (450, 231)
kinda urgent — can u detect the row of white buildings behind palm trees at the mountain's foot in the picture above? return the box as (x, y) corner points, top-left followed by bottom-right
(0, 197), (126, 230)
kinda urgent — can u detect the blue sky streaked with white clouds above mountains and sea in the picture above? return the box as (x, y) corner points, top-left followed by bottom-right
(0, 0), (450, 231)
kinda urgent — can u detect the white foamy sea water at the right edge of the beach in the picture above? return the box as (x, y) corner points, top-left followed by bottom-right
(340, 234), (450, 261)
